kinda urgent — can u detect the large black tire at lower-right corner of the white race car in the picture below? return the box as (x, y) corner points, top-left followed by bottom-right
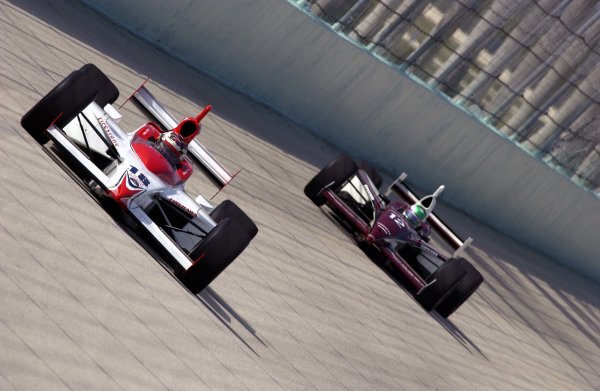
(179, 208), (258, 294)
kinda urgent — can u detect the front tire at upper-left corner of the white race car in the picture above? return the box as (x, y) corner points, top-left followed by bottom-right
(21, 69), (97, 144)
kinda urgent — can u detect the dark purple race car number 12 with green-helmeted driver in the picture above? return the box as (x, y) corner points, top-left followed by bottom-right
(304, 155), (483, 318)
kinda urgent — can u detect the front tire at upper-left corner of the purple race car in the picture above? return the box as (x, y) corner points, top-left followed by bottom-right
(304, 154), (358, 206)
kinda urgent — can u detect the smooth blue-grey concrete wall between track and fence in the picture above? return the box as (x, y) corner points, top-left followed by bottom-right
(82, 0), (600, 281)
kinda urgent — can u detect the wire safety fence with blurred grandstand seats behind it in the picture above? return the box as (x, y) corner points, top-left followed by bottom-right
(296, 0), (600, 195)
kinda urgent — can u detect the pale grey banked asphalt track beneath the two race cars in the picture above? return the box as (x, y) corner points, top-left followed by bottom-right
(0, 1), (600, 390)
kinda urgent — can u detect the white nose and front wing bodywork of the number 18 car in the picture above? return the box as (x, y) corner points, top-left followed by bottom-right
(47, 102), (223, 270)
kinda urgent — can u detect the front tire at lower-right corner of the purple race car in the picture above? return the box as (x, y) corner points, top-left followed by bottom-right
(415, 258), (467, 311)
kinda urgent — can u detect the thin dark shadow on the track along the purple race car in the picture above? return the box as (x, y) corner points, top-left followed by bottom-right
(321, 208), (489, 361)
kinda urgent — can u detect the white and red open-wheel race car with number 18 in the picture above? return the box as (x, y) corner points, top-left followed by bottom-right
(21, 64), (258, 294)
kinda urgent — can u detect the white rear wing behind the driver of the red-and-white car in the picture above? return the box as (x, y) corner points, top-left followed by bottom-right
(133, 85), (233, 186)
